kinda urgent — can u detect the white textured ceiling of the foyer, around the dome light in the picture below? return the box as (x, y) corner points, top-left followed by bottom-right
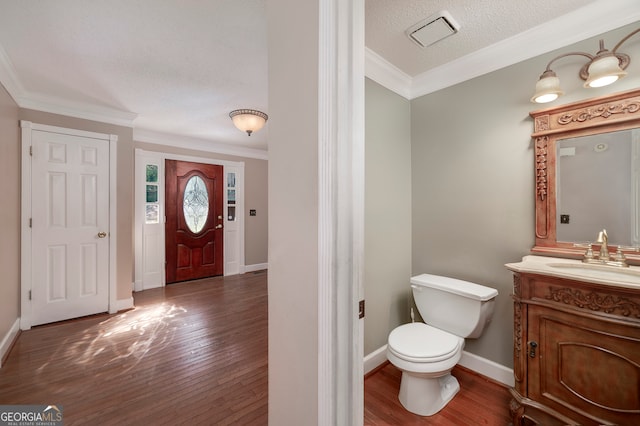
(0, 0), (268, 149)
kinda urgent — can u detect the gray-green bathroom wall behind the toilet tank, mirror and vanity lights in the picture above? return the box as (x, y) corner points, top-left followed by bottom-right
(408, 24), (640, 367)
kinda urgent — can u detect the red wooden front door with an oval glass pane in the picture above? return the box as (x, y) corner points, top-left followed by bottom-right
(165, 160), (224, 283)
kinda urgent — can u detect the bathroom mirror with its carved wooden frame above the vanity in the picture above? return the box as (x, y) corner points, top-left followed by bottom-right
(530, 90), (640, 264)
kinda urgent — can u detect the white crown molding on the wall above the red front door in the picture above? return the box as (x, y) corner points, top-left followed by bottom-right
(133, 127), (269, 160)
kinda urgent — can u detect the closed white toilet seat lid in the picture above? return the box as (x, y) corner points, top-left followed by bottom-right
(387, 322), (464, 363)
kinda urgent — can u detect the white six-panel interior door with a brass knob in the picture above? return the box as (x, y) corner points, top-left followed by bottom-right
(31, 130), (109, 325)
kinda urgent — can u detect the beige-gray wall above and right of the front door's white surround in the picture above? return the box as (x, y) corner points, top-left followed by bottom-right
(135, 142), (268, 265)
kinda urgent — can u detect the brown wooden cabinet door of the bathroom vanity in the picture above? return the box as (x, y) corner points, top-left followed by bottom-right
(528, 305), (640, 425)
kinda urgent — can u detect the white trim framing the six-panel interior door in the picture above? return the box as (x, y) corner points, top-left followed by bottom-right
(20, 120), (118, 330)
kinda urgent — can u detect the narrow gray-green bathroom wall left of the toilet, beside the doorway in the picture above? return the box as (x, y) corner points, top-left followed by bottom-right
(364, 79), (411, 354)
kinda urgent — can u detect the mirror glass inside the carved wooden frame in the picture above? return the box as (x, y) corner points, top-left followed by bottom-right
(556, 129), (640, 246)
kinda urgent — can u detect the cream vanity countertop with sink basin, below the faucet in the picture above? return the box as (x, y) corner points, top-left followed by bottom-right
(506, 255), (640, 289)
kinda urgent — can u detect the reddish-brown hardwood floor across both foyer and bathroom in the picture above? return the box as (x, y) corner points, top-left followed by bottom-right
(0, 272), (509, 426)
